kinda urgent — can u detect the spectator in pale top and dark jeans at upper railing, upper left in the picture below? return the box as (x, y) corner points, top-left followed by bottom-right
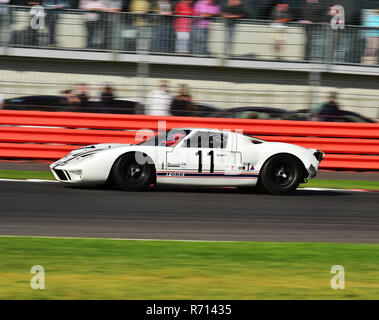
(79, 0), (106, 49)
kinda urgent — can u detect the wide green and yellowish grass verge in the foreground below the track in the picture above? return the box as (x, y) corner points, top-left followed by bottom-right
(0, 237), (379, 299)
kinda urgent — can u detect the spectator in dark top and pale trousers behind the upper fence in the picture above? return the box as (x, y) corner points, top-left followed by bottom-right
(270, 3), (291, 60)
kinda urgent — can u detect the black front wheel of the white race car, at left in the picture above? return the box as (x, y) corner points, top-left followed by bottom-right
(111, 153), (155, 191)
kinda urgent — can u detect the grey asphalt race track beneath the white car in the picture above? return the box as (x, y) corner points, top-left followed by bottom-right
(0, 181), (379, 243)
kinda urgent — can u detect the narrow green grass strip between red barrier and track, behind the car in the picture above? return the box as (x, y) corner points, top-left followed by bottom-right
(0, 170), (379, 190)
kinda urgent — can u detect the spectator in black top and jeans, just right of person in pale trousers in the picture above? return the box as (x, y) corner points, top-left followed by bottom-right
(299, 0), (330, 61)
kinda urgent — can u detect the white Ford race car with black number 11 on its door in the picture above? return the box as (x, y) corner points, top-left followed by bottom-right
(50, 128), (324, 194)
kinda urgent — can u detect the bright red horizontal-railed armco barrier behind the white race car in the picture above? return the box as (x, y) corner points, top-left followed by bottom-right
(0, 110), (379, 170)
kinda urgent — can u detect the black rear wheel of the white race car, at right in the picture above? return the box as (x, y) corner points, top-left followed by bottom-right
(259, 154), (303, 194)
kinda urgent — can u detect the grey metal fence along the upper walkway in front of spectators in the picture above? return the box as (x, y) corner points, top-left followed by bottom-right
(0, 6), (379, 65)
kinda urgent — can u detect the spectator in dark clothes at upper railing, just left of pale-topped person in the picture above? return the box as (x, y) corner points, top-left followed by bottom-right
(42, 0), (70, 47)
